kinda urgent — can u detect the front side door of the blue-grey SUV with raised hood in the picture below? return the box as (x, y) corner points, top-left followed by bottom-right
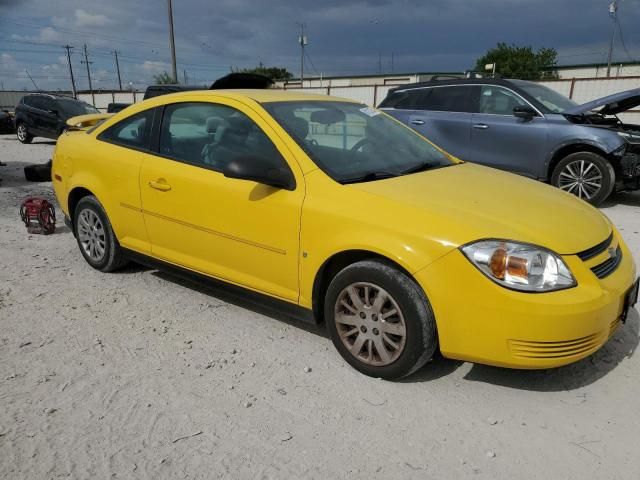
(467, 85), (549, 178)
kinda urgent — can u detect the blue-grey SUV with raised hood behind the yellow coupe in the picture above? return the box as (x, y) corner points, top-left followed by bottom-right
(380, 78), (640, 205)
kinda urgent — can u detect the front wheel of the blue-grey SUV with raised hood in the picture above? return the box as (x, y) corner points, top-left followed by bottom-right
(551, 152), (616, 205)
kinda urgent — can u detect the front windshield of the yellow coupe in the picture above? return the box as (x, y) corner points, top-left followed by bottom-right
(264, 100), (454, 183)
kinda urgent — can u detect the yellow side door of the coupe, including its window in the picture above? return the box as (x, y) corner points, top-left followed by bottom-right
(140, 99), (305, 301)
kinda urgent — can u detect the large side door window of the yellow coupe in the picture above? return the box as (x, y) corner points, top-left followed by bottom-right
(160, 103), (286, 171)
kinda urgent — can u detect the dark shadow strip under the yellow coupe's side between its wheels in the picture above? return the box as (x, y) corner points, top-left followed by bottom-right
(152, 270), (328, 338)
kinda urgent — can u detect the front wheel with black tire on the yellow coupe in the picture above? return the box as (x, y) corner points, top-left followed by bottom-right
(324, 260), (438, 380)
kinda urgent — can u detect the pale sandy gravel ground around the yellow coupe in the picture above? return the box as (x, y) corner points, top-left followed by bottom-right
(0, 132), (640, 479)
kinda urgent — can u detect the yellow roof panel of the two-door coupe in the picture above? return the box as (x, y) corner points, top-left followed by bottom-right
(150, 89), (361, 104)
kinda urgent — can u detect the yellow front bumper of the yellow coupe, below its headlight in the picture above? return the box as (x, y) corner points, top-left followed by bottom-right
(415, 232), (636, 369)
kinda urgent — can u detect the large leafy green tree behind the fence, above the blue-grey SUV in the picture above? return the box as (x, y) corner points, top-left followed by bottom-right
(475, 42), (558, 80)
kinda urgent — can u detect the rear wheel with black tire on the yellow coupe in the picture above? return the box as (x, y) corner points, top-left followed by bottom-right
(73, 196), (127, 272)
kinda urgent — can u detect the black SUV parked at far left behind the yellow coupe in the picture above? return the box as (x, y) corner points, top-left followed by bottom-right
(15, 93), (100, 143)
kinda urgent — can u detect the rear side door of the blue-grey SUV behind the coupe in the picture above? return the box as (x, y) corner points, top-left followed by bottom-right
(380, 85), (476, 159)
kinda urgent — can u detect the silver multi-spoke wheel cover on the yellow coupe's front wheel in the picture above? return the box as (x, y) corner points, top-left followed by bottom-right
(334, 282), (407, 366)
